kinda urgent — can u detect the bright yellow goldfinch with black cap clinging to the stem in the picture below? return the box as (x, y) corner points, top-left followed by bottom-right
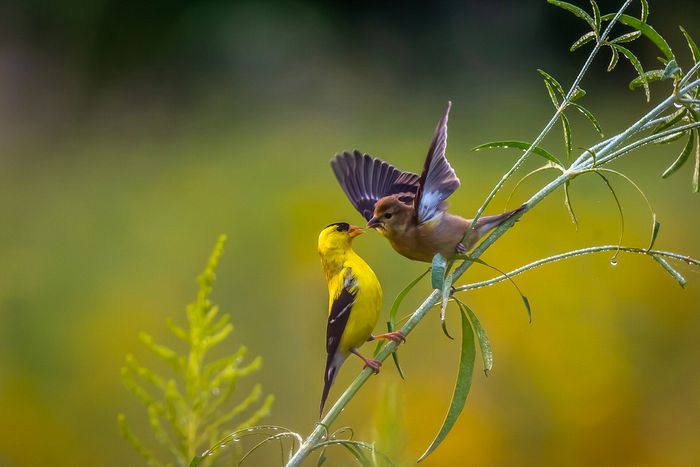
(318, 222), (405, 415)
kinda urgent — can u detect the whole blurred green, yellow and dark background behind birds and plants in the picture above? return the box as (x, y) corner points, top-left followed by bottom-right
(0, 0), (700, 466)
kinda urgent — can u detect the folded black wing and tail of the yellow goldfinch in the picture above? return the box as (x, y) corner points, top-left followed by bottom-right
(321, 268), (357, 414)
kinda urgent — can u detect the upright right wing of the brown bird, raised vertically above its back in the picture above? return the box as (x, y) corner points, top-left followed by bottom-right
(414, 102), (459, 224)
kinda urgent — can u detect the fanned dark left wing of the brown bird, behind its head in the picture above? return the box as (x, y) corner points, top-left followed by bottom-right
(331, 149), (420, 220)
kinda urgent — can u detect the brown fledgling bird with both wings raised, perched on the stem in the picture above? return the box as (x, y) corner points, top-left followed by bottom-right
(331, 102), (523, 262)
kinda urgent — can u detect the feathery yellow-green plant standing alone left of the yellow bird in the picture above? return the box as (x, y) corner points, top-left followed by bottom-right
(117, 235), (274, 466)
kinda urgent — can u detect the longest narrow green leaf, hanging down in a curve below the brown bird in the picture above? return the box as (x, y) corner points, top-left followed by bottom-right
(418, 311), (476, 462)
